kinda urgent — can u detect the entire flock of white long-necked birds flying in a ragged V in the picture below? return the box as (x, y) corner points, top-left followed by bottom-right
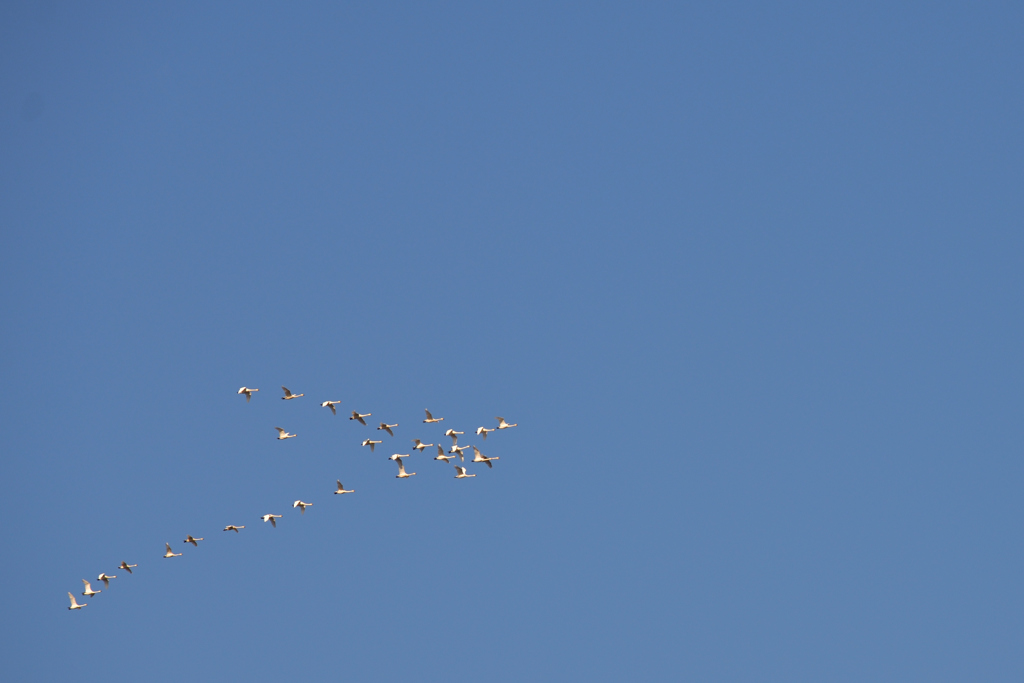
(68, 387), (519, 609)
